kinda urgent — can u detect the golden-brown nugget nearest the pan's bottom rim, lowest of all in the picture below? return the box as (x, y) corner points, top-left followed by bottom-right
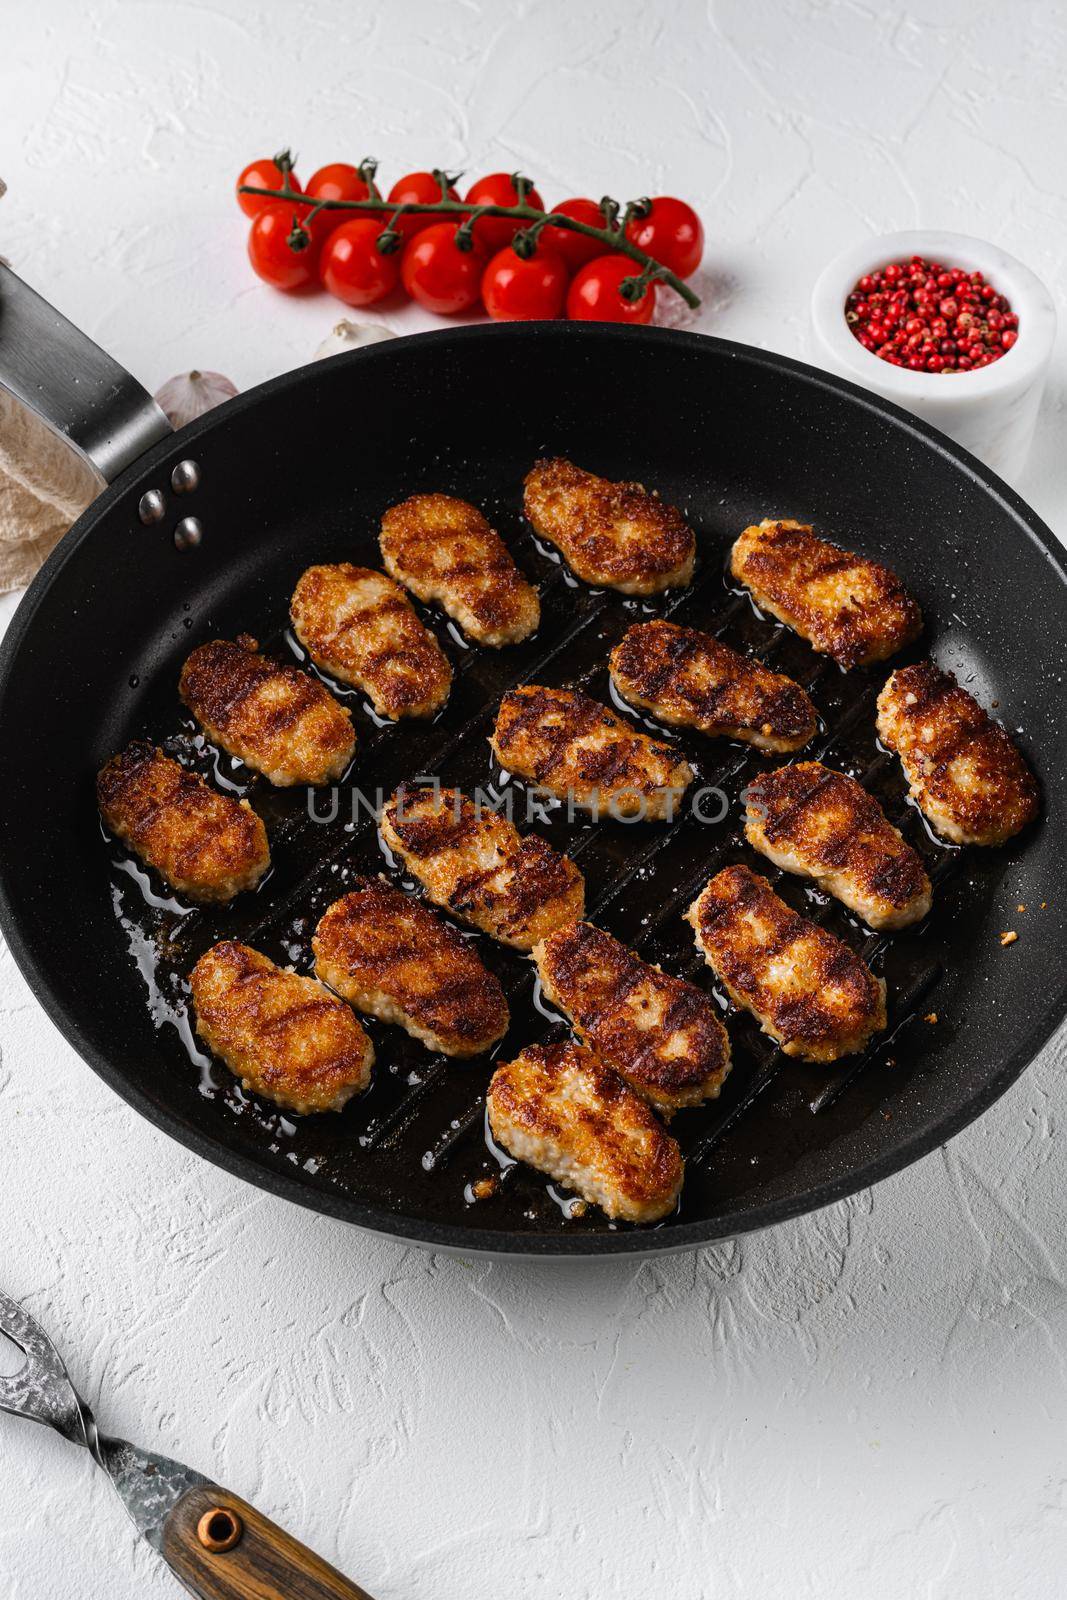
(486, 1045), (685, 1222)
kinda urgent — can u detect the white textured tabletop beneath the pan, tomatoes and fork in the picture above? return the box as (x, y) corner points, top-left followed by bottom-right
(0, 0), (1067, 1600)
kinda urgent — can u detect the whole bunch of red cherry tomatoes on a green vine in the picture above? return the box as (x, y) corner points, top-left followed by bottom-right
(238, 150), (704, 323)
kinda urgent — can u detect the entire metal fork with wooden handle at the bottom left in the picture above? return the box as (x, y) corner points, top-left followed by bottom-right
(0, 1293), (371, 1600)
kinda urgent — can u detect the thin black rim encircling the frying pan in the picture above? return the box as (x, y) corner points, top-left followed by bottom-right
(0, 323), (1067, 1259)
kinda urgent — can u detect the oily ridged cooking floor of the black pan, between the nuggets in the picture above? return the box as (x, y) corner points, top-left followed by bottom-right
(99, 483), (991, 1232)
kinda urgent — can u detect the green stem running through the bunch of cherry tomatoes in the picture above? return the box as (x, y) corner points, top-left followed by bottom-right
(238, 172), (701, 310)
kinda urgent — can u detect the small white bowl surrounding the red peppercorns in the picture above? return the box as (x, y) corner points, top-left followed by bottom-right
(811, 230), (1056, 480)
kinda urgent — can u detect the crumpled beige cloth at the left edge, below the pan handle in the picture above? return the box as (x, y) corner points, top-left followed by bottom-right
(0, 170), (104, 592)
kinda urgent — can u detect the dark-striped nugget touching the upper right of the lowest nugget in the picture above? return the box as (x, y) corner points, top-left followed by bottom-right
(533, 922), (729, 1115)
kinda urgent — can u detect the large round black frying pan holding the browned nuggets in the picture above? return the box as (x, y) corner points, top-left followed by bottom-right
(0, 274), (1067, 1254)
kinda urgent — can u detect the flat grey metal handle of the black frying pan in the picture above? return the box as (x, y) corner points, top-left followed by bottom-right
(0, 262), (173, 483)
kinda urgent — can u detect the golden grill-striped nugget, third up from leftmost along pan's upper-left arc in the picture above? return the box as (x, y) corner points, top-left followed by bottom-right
(290, 562), (453, 720)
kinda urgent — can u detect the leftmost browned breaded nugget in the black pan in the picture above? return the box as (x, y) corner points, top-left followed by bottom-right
(96, 739), (270, 901)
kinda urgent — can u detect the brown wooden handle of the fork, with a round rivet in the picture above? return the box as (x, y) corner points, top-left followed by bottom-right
(162, 1483), (371, 1600)
